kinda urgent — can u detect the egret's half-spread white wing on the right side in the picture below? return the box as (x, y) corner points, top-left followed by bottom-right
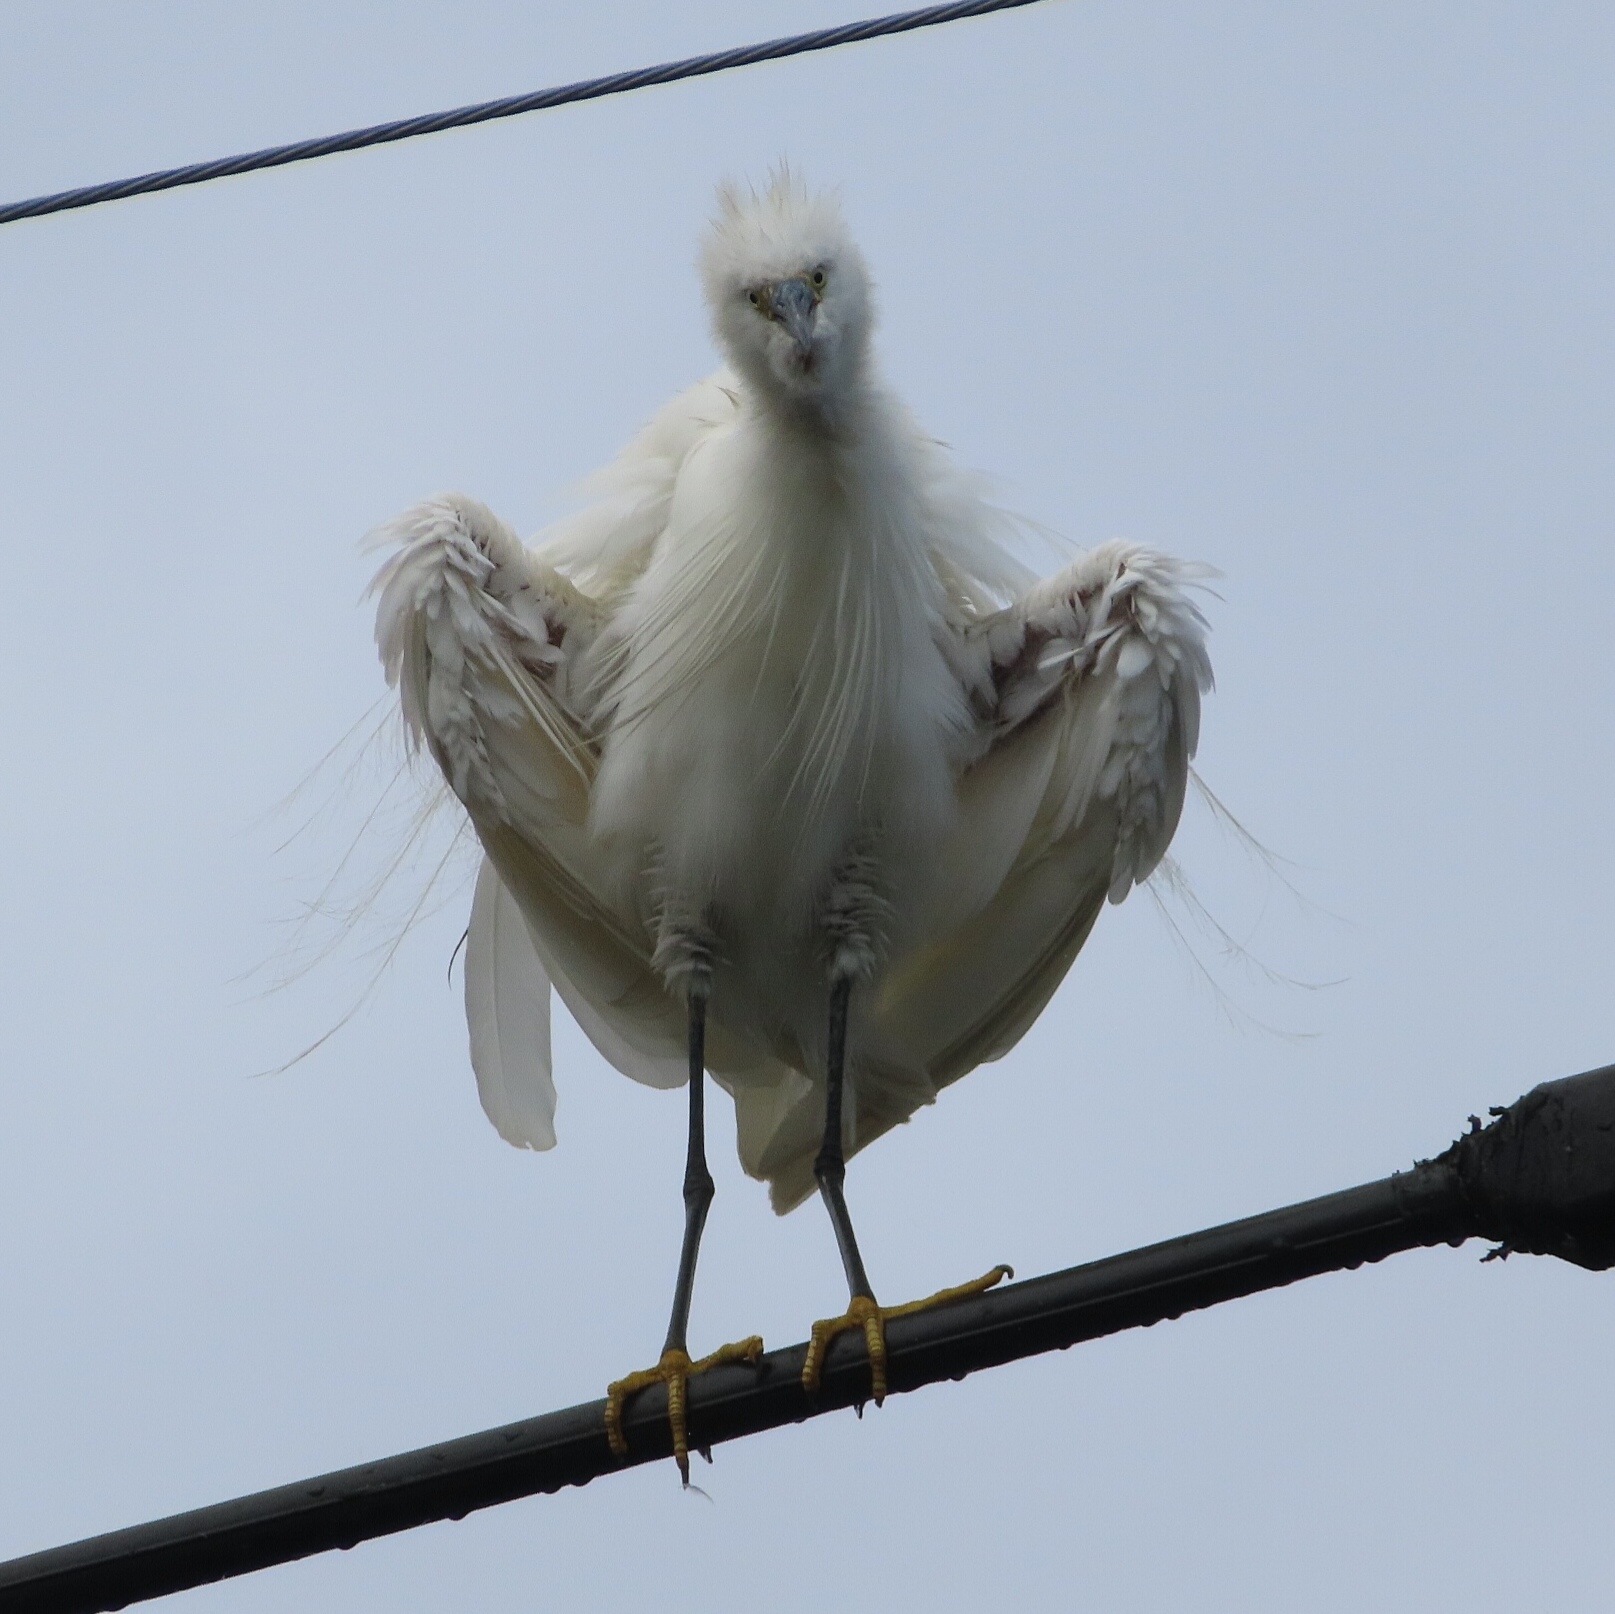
(874, 543), (1211, 1087)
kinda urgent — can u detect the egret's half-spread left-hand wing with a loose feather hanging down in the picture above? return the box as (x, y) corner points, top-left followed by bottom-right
(376, 496), (685, 1111)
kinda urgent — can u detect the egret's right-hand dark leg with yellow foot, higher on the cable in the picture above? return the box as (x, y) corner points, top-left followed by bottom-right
(803, 856), (1014, 1407)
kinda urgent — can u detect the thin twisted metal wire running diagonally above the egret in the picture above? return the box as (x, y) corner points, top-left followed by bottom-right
(0, 0), (1038, 225)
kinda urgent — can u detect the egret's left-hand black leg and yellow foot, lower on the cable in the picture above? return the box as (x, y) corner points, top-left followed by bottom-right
(606, 917), (762, 1485)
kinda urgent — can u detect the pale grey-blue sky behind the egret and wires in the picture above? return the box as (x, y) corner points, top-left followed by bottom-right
(0, 0), (1615, 1614)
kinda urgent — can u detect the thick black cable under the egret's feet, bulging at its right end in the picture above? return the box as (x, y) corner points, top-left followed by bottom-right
(0, 1065), (1615, 1614)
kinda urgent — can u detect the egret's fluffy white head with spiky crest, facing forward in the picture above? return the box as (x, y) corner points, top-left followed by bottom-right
(701, 168), (874, 407)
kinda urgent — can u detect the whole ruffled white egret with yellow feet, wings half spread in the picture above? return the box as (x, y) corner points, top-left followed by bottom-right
(376, 171), (1211, 1477)
